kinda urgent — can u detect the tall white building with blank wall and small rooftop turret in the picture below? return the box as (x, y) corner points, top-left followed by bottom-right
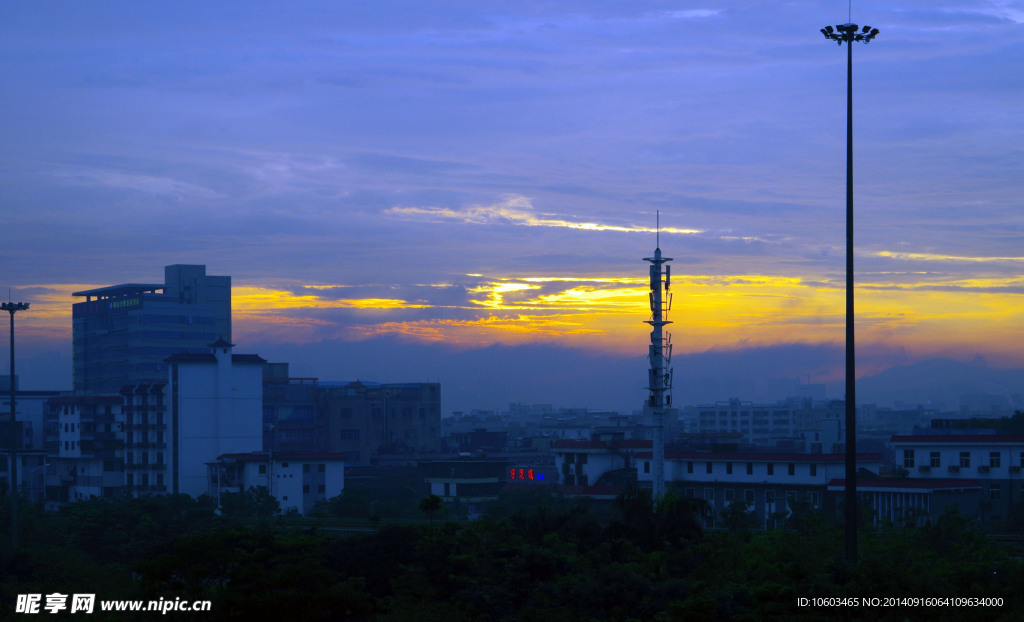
(167, 339), (266, 497)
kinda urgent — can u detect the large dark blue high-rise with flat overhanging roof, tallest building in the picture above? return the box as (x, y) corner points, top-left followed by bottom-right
(72, 264), (231, 395)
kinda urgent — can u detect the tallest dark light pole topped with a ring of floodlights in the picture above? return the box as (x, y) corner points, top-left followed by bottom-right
(821, 24), (879, 564)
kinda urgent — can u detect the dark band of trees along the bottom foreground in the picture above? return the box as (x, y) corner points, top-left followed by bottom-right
(0, 490), (1024, 622)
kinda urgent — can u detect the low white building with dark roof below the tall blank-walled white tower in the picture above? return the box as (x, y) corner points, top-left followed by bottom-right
(207, 453), (345, 515)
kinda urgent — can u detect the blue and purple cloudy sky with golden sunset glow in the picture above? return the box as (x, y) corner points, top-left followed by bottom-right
(0, 0), (1024, 410)
